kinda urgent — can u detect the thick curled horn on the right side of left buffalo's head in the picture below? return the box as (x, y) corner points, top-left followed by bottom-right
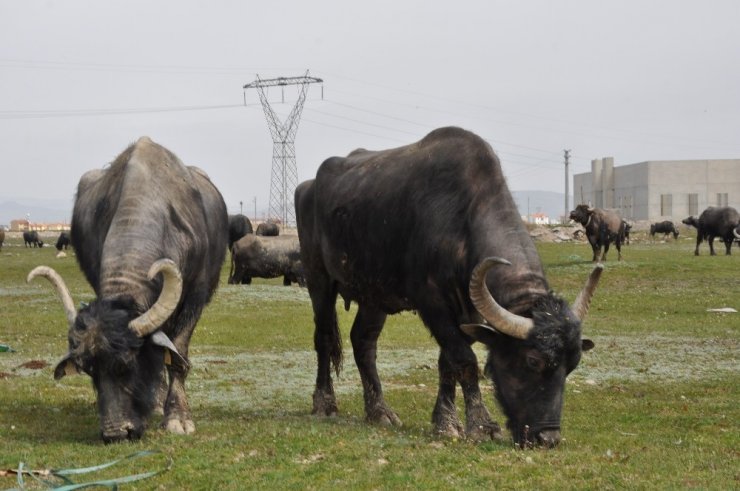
(128, 259), (182, 337)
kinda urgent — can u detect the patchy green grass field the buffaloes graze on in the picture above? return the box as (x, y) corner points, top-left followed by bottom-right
(0, 233), (740, 490)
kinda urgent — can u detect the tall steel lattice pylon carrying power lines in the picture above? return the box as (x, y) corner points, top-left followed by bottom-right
(244, 71), (323, 226)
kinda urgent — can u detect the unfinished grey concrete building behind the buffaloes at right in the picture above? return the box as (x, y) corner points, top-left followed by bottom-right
(573, 157), (740, 222)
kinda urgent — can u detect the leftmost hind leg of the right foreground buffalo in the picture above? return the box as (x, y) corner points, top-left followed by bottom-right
(309, 275), (342, 416)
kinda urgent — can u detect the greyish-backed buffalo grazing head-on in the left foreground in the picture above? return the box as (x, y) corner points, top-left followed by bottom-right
(28, 137), (228, 442)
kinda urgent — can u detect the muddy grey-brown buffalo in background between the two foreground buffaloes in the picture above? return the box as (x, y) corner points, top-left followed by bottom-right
(229, 234), (306, 286)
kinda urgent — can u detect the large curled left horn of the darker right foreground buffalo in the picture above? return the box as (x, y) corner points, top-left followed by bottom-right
(470, 257), (534, 339)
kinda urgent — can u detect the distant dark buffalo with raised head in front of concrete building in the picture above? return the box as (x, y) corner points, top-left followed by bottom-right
(570, 205), (624, 262)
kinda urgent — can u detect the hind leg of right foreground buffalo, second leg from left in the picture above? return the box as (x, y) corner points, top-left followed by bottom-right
(350, 305), (401, 426)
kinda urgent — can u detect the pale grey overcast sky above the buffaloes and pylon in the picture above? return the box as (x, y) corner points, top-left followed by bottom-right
(0, 0), (740, 219)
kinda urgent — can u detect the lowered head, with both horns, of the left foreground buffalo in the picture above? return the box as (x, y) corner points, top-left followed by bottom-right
(28, 259), (187, 443)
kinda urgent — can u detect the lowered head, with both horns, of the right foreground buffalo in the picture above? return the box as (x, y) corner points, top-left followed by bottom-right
(461, 258), (603, 447)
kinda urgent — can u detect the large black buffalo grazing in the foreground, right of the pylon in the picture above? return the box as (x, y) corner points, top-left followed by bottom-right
(295, 128), (601, 446)
